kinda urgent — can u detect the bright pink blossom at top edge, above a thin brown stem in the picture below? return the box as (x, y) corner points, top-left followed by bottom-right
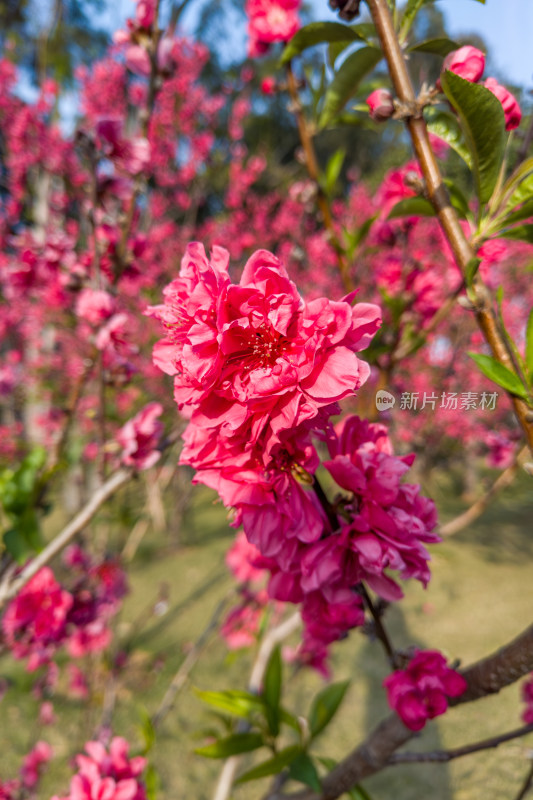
(246, 0), (301, 58)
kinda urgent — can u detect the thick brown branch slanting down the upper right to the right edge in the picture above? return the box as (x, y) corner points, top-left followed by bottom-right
(367, 0), (533, 451)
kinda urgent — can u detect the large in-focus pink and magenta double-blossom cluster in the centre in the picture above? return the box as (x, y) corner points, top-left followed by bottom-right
(148, 244), (438, 668)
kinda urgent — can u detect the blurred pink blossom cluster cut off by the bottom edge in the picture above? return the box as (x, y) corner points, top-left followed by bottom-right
(52, 736), (146, 800)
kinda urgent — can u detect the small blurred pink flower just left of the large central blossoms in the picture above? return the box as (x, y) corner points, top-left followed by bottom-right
(117, 403), (163, 469)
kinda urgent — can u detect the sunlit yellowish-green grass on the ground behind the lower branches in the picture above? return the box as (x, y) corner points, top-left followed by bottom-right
(0, 468), (533, 800)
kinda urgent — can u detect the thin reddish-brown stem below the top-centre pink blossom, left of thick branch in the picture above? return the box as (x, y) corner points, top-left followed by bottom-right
(287, 62), (354, 292)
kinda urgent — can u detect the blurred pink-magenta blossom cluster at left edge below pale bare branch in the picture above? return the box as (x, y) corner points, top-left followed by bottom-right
(2, 546), (126, 671)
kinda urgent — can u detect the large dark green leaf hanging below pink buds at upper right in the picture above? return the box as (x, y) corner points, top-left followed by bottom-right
(441, 70), (507, 203)
